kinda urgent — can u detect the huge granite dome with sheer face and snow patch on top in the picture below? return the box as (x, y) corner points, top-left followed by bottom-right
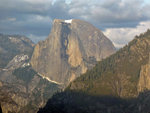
(31, 19), (115, 84)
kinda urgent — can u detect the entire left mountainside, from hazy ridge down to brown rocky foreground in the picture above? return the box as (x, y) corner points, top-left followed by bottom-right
(0, 34), (60, 113)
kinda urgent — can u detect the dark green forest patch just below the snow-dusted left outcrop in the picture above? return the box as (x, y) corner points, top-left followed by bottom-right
(13, 66), (37, 84)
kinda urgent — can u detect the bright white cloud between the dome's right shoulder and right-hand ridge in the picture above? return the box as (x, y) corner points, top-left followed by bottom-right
(104, 21), (150, 48)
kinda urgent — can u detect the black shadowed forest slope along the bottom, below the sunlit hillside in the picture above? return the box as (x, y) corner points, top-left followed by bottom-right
(38, 91), (150, 113)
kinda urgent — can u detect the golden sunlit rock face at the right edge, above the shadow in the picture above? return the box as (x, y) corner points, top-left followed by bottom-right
(138, 55), (150, 92)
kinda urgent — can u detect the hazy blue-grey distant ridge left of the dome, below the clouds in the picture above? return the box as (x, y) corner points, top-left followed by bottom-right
(0, 34), (34, 68)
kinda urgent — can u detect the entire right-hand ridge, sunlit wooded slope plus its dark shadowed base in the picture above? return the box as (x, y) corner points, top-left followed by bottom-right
(38, 30), (150, 113)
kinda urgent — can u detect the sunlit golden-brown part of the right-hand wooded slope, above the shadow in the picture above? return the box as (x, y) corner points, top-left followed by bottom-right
(67, 30), (150, 98)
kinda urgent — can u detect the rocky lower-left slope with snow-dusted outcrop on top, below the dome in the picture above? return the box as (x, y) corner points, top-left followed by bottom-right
(0, 54), (60, 113)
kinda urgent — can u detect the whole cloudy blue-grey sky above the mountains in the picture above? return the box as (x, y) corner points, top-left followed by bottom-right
(0, 0), (150, 48)
